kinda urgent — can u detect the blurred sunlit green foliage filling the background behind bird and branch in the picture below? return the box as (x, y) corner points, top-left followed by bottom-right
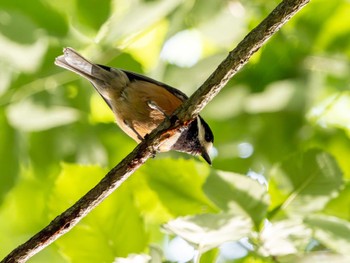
(0, 0), (350, 263)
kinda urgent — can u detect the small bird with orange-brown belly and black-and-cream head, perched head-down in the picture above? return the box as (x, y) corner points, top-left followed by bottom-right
(55, 48), (214, 164)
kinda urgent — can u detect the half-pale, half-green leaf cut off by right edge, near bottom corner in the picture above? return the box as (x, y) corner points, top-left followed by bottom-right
(304, 215), (350, 256)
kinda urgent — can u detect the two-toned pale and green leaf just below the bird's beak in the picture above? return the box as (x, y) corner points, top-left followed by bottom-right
(204, 171), (268, 227)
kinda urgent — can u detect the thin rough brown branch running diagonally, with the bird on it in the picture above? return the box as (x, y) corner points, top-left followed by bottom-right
(1, 0), (310, 263)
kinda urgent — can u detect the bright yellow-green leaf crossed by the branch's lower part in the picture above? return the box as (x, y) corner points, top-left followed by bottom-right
(50, 164), (147, 262)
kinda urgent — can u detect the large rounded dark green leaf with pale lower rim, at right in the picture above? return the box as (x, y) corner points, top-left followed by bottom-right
(269, 149), (343, 218)
